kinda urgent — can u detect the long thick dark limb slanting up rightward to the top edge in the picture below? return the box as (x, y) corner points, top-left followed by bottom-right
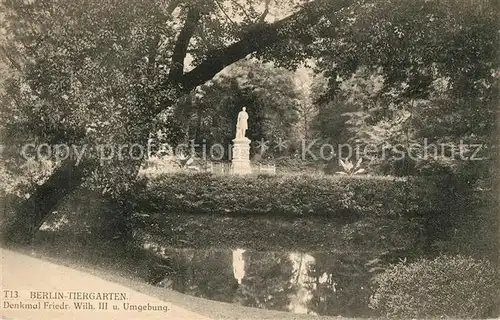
(180, 0), (353, 91)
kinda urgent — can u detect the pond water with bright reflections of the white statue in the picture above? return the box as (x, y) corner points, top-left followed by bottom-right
(145, 244), (372, 317)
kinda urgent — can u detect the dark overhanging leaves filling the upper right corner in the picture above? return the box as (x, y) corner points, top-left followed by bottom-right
(310, 0), (498, 99)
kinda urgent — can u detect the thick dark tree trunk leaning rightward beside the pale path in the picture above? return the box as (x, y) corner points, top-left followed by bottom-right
(3, 160), (90, 244)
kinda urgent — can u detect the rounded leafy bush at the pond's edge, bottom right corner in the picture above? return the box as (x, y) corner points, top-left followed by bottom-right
(370, 256), (500, 318)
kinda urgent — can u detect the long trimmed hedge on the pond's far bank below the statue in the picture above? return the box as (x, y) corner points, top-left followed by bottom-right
(132, 173), (432, 221)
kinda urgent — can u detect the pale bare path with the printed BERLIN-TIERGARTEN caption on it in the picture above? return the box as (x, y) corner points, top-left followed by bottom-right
(0, 248), (209, 320)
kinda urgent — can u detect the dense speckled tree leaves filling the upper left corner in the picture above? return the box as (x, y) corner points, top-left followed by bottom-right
(2, 1), (180, 190)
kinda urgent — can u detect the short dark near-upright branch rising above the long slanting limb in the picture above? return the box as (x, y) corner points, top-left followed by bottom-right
(168, 6), (201, 82)
